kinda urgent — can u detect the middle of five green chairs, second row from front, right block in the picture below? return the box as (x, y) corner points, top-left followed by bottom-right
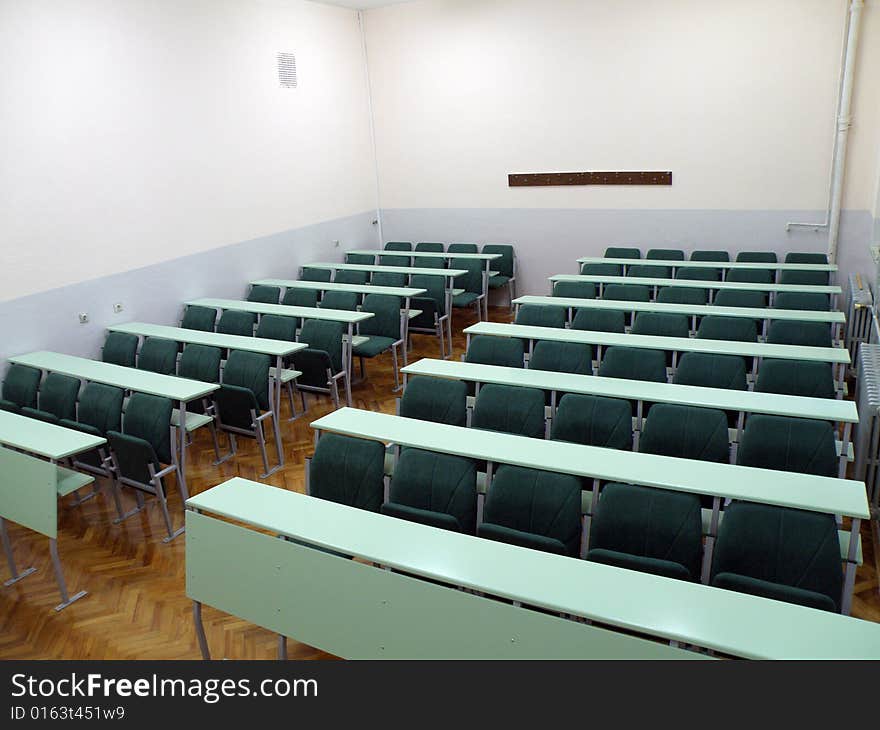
(550, 393), (633, 451)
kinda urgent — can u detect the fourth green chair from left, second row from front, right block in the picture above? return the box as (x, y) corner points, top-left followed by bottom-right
(639, 403), (730, 464)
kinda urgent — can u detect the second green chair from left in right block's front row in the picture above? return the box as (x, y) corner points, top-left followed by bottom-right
(382, 449), (477, 535)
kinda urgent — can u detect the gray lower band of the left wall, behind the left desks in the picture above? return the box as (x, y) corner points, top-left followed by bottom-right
(0, 211), (378, 369)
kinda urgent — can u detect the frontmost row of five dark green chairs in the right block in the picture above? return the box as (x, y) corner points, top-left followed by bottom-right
(306, 430), (843, 611)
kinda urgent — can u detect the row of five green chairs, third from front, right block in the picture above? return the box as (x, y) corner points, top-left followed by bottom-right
(464, 335), (836, 398)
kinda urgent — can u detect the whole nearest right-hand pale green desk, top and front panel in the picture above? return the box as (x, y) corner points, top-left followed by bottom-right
(186, 479), (880, 659)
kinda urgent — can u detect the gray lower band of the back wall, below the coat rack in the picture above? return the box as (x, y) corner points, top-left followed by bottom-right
(382, 208), (874, 302)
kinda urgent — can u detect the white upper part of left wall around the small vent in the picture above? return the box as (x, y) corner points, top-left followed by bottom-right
(0, 0), (376, 306)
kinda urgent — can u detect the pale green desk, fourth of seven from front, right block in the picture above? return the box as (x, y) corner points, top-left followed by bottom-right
(464, 322), (850, 389)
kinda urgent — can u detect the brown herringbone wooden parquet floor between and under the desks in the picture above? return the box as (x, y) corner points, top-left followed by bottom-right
(0, 308), (880, 659)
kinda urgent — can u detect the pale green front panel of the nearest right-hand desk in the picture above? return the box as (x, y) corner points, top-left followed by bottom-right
(186, 511), (705, 659)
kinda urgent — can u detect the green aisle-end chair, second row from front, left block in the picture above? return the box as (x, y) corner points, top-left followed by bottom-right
(214, 350), (283, 477)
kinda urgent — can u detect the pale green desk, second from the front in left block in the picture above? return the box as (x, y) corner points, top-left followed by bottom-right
(9, 351), (220, 501)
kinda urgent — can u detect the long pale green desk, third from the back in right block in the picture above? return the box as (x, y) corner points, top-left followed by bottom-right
(513, 296), (846, 340)
